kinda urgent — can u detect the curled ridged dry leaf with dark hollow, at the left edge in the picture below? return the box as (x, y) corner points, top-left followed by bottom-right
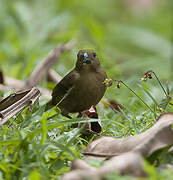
(0, 87), (40, 125)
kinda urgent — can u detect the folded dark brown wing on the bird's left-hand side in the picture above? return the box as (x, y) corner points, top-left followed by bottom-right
(52, 70), (80, 104)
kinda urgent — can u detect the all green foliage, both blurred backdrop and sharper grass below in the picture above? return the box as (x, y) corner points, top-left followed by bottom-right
(0, 0), (173, 180)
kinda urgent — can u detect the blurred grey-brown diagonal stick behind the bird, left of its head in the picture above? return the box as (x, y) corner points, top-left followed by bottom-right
(21, 40), (74, 89)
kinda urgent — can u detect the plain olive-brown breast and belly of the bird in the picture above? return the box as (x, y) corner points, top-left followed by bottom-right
(58, 70), (106, 112)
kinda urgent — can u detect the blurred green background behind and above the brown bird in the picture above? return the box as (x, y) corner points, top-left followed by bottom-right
(0, 0), (173, 97)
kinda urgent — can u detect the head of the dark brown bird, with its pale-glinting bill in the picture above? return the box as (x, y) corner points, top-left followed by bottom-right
(76, 50), (100, 70)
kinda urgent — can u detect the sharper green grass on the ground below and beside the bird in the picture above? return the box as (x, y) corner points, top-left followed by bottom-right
(0, 69), (173, 179)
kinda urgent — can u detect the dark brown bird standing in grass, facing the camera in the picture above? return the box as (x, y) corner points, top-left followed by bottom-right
(45, 50), (107, 118)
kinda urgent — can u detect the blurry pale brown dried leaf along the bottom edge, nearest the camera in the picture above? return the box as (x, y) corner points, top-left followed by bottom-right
(60, 152), (147, 180)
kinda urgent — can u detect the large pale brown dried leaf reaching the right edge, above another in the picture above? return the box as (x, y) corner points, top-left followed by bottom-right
(87, 113), (173, 156)
